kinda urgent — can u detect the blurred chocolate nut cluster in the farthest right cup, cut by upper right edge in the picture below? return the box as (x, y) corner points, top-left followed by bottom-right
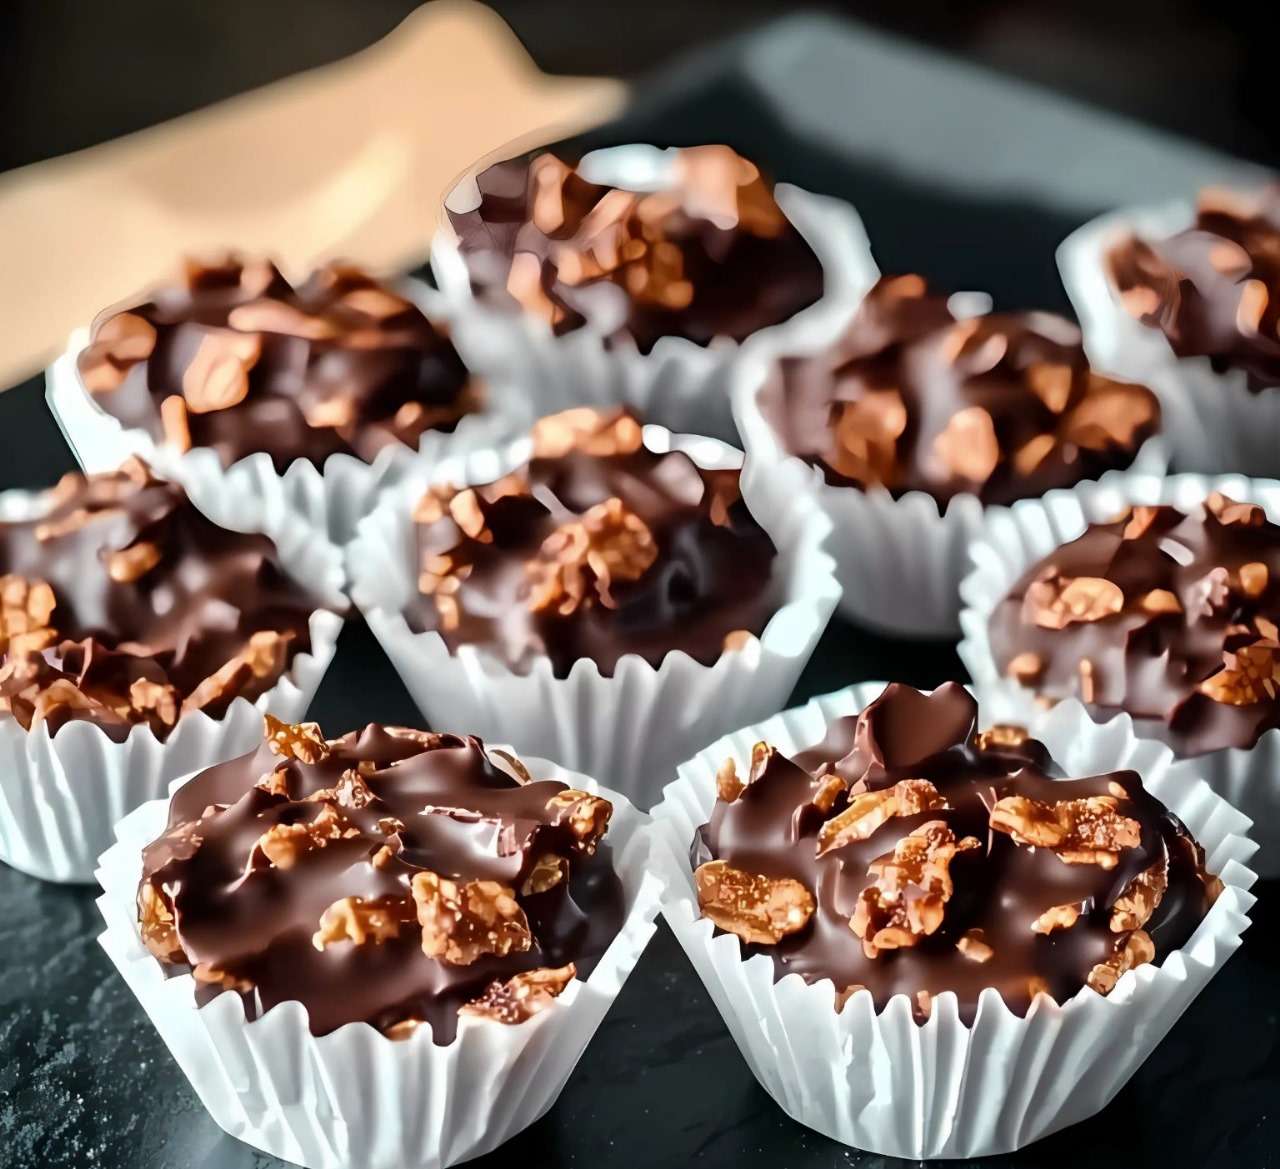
(1106, 184), (1280, 391)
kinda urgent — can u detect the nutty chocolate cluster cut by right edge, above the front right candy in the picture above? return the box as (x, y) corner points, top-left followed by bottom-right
(989, 494), (1280, 755)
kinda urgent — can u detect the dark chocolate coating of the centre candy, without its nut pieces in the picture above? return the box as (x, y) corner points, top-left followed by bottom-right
(404, 415), (777, 677)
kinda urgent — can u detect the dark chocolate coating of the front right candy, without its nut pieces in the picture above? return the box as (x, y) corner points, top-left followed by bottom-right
(692, 682), (1208, 1022)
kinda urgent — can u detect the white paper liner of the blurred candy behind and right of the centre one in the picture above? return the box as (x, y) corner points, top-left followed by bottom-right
(732, 294), (1167, 638)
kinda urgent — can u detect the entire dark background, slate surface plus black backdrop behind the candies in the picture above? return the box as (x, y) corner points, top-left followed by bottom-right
(0, 0), (1280, 1169)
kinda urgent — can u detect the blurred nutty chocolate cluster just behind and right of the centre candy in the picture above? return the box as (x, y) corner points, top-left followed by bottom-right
(759, 275), (1160, 503)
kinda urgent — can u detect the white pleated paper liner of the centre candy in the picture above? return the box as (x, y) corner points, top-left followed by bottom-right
(347, 426), (840, 808)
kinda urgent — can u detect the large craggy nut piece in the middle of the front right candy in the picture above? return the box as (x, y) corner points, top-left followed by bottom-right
(849, 819), (979, 958)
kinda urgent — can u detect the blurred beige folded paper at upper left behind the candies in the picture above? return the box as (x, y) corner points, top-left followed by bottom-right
(0, 0), (625, 388)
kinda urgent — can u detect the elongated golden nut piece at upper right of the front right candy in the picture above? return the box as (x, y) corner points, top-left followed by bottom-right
(991, 795), (1142, 868)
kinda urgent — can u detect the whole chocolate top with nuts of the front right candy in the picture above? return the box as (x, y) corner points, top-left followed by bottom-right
(692, 682), (1221, 1020)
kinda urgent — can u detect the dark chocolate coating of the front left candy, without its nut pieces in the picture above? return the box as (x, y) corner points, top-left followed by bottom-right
(142, 723), (625, 1045)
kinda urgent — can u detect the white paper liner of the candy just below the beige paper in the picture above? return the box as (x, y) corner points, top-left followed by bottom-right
(45, 277), (524, 545)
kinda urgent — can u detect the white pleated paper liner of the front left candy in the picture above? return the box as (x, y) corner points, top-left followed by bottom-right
(97, 758), (662, 1169)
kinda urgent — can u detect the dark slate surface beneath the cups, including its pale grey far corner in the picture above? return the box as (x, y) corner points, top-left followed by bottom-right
(0, 22), (1280, 1169)
